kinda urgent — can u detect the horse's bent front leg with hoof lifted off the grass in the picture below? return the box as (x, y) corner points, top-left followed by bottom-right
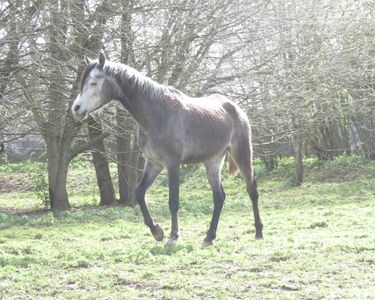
(135, 160), (164, 241)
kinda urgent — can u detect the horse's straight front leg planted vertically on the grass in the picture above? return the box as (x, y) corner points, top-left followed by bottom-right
(167, 163), (180, 244)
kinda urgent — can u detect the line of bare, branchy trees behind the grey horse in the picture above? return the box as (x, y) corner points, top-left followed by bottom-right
(0, 0), (375, 211)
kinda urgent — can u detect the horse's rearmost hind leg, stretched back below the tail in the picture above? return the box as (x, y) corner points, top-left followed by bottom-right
(230, 138), (263, 240)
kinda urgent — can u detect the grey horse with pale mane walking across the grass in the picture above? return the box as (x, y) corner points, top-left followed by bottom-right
(71, 53), (263, 246)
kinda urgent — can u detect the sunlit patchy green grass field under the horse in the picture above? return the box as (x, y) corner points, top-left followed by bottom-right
(0, 157), (375, 299)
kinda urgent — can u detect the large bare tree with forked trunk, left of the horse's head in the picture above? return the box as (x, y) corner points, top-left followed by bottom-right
(9, 0), (116, 211)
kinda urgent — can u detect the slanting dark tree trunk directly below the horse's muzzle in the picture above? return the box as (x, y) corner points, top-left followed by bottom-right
(88, 118), (116, 205)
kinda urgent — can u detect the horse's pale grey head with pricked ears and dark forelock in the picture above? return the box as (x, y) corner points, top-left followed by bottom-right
(72, 53), (113, 120)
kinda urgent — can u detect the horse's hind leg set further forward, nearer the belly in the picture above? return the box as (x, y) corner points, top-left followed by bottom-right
(203, 159), (225, 246)
